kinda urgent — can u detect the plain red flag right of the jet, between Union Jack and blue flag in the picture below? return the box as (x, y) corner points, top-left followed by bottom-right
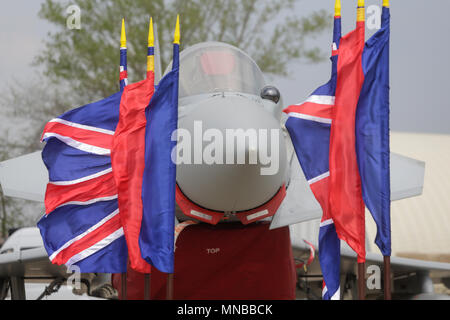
(329, 21), (366, 262)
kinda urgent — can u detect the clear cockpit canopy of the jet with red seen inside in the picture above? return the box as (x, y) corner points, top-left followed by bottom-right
(169, 42), (265, 98)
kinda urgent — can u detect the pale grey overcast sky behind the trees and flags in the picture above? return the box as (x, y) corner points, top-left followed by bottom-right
(0, 0), (450, 134)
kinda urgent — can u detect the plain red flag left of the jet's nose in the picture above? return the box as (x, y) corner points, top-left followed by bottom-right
(111, 73), (154, 273)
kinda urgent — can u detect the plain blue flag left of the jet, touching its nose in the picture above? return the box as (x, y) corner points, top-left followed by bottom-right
(139, 44), (180, 273)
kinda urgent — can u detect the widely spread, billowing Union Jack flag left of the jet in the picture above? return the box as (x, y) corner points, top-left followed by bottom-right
(38, 92), (128, 273)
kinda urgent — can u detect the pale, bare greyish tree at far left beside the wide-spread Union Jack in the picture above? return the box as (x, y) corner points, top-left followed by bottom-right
(0, 77), (67, 236)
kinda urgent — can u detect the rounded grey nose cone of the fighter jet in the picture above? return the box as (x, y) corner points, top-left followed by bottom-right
(177, 96), (287, 212)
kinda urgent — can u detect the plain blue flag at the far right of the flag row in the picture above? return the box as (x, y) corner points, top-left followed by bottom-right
(356, 7), (391, 256)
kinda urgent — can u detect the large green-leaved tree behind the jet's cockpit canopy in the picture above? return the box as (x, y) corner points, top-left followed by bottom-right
(35, 0), (331, 101)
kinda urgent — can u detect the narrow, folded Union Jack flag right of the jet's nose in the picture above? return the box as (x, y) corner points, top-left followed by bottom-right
(284, 16), (341, 300)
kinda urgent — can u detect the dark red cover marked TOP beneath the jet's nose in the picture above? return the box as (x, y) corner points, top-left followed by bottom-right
(113, 222), (296, 300)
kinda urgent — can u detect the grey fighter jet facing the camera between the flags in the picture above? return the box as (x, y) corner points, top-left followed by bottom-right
(0, 42), (450, 294)
